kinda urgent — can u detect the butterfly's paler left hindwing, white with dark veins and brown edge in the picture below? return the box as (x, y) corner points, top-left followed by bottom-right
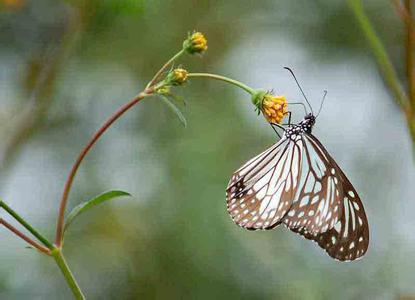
(226, 138), (303, 230)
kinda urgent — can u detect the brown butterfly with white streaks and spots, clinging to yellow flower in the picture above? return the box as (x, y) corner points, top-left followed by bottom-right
(226, 69), (369, 261)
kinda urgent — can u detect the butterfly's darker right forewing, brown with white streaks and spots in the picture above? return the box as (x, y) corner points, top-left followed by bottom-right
(284, 134), (369, 261)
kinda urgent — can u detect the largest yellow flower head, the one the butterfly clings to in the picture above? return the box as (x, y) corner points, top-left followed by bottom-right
(259, 93), (288, 124)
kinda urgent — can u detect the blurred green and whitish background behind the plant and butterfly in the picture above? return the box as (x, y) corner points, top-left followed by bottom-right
(0, 0), (415, 299)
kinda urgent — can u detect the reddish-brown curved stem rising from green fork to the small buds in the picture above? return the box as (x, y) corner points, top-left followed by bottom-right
(55, 88), (154, 248)
